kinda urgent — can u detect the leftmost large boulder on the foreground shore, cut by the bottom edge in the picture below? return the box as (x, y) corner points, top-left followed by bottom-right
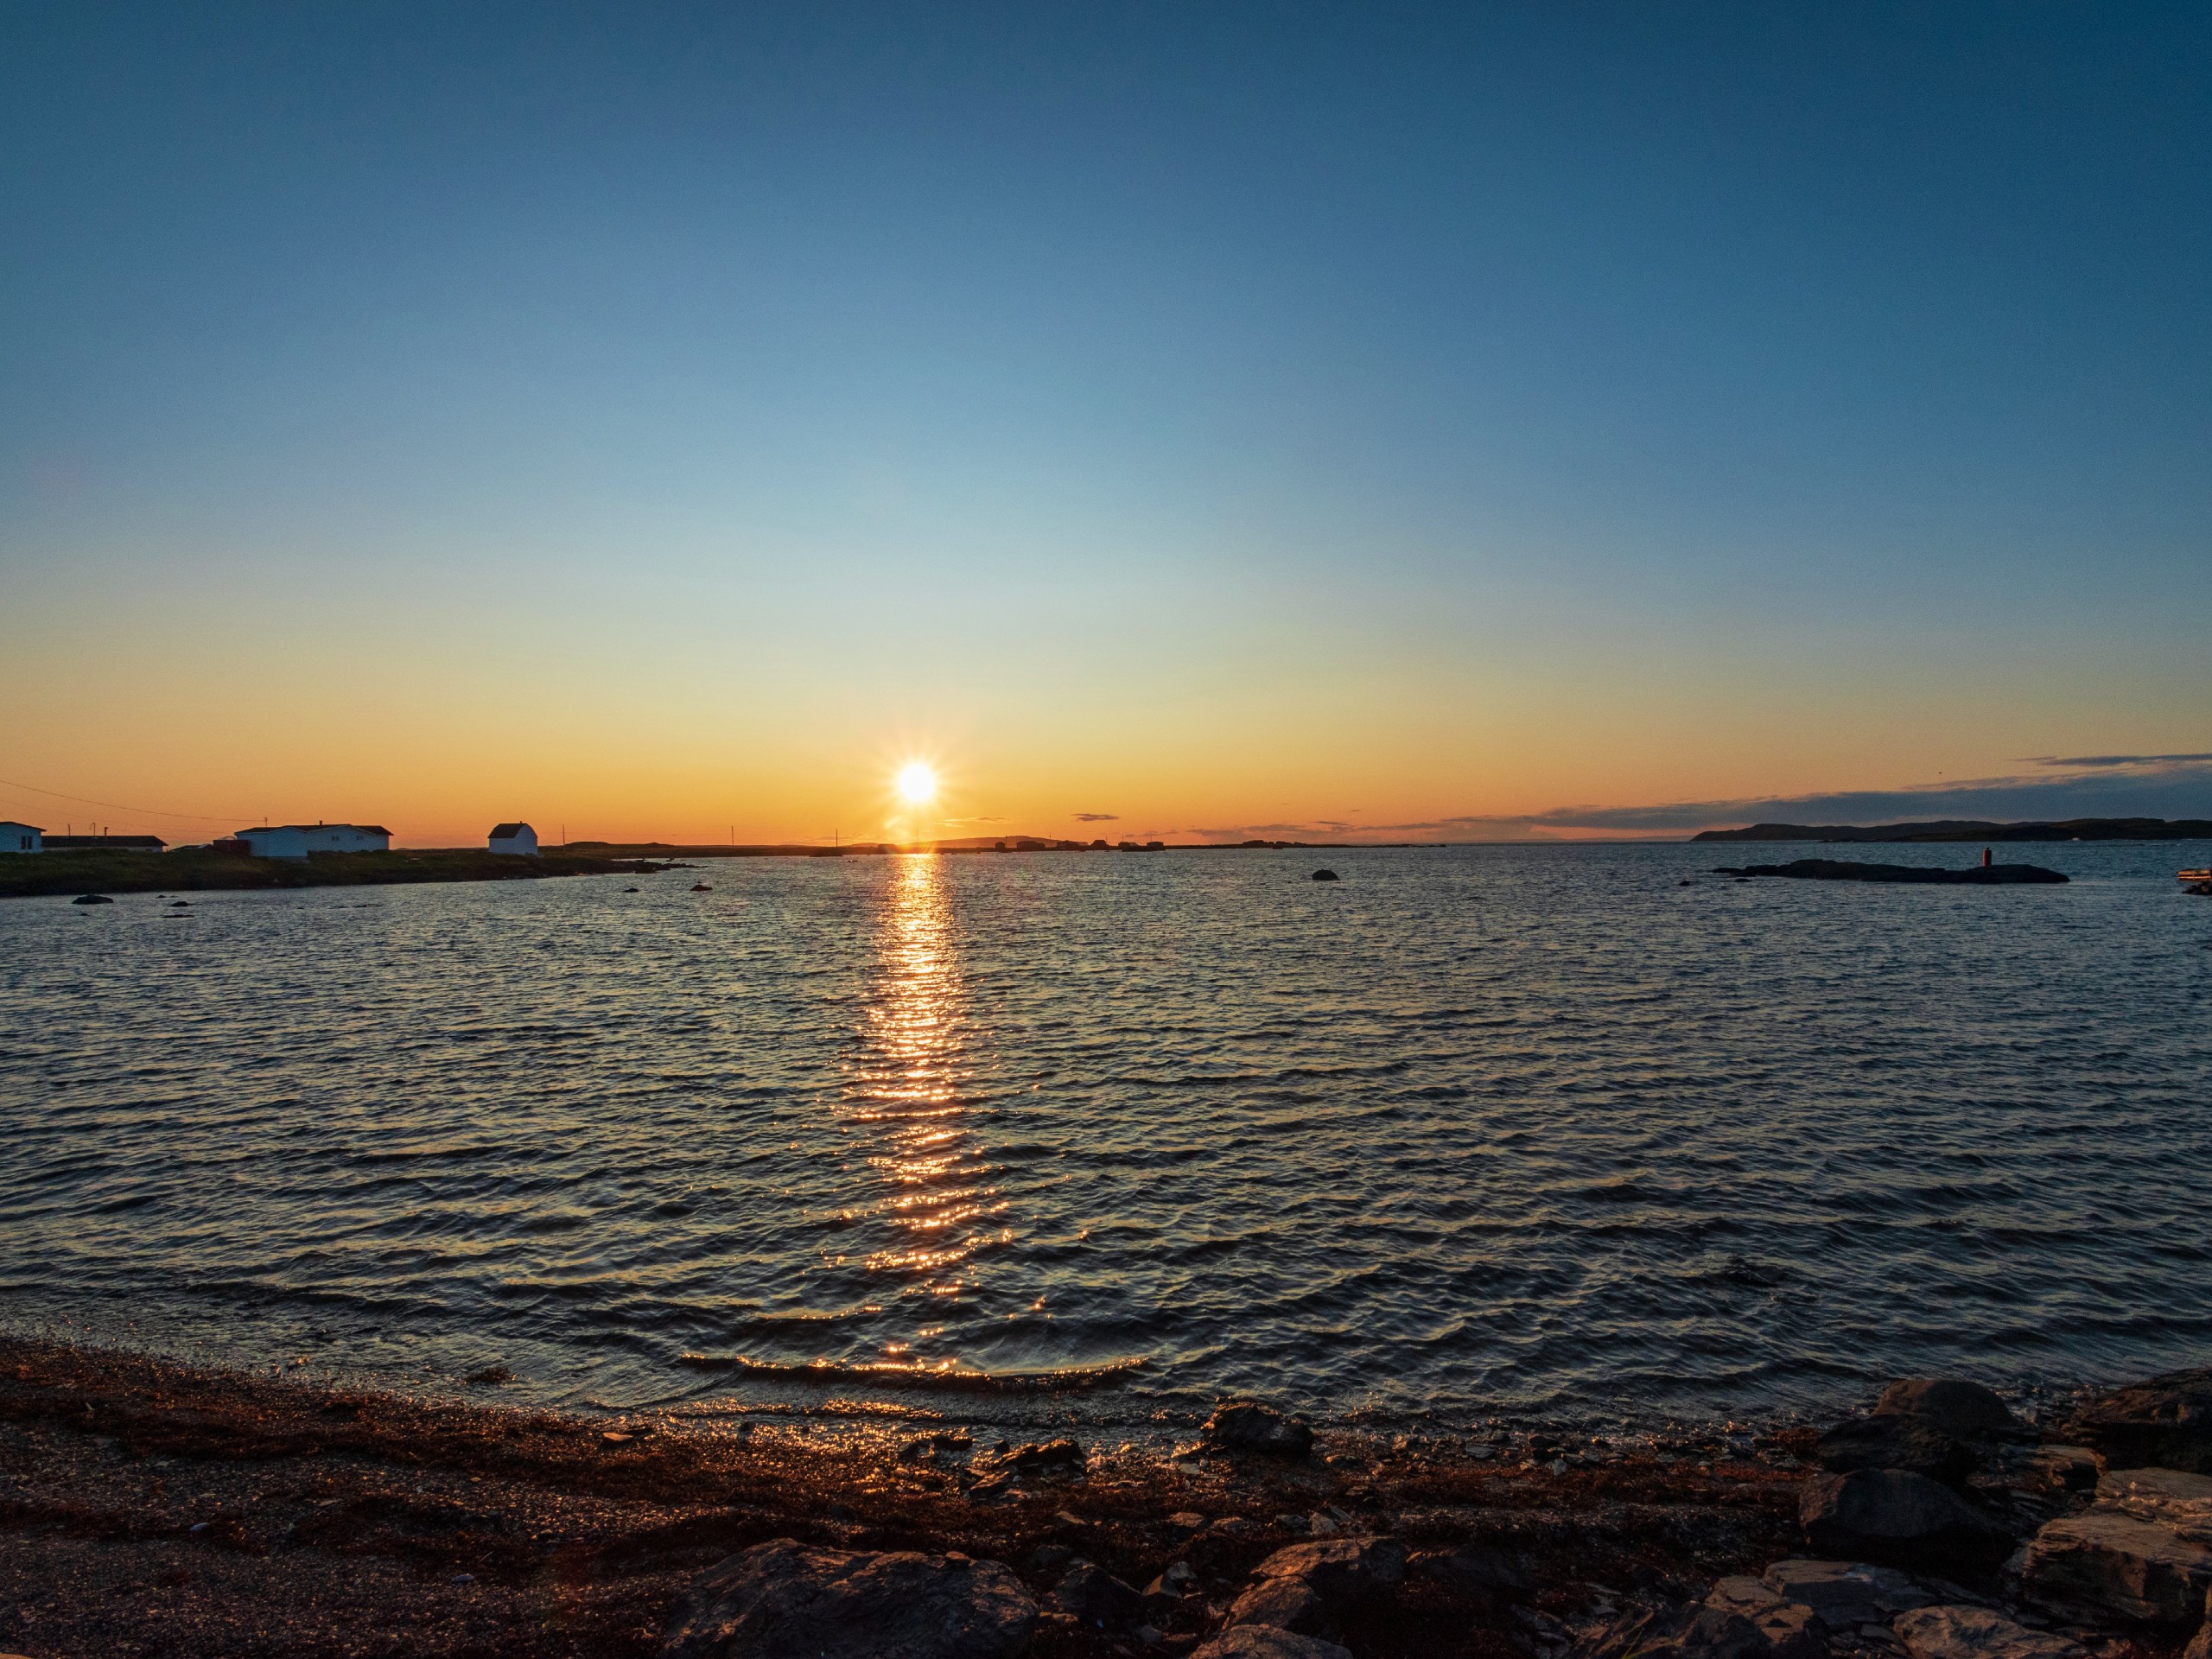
(661, 1537), (1038, 1659)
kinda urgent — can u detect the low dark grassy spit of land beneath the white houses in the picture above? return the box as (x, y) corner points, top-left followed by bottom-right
(0, 847), (668, 898)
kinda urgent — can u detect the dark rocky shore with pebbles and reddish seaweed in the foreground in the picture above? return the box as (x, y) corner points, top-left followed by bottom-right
(0, 1338), (2212, 1659)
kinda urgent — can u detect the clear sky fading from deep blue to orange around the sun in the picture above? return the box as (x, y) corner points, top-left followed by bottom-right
(0, 0), (2212, 845)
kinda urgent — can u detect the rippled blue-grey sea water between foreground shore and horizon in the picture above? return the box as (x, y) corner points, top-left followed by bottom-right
(0, 842), (2212, 1425)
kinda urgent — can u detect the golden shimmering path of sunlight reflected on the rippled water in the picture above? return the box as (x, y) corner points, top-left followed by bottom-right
(845, 854), (1004, 1363)
